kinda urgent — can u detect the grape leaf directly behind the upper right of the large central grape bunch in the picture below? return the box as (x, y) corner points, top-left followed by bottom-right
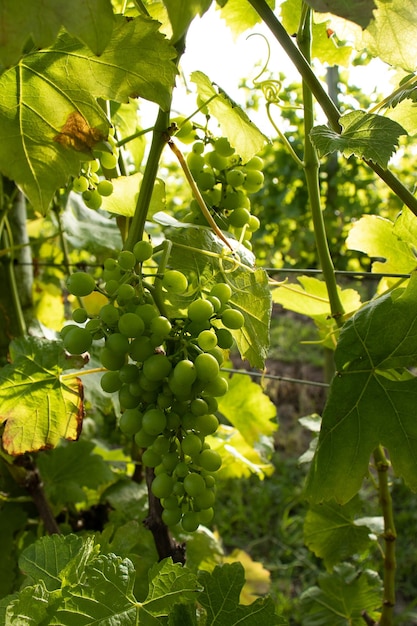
(156, 225), (271, 369)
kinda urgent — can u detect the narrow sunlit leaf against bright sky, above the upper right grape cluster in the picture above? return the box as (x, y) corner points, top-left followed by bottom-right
(191, 69), (268, 163)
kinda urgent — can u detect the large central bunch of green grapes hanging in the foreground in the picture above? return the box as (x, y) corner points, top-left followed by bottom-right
(61, 241), (244, 532)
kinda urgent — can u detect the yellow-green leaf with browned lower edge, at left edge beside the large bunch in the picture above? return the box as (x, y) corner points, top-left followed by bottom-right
(0, 337), (83, 455)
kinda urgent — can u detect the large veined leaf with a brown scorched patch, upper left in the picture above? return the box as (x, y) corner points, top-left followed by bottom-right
(0, 17), (176, 213)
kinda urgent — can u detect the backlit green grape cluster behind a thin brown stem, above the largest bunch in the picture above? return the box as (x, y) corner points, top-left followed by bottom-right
(176, 129), (264, 249)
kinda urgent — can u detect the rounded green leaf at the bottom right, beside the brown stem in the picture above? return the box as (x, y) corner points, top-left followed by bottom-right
(300, 563), (382, 626)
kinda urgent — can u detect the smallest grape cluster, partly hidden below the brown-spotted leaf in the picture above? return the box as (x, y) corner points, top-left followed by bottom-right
(72, 135), (118, 210)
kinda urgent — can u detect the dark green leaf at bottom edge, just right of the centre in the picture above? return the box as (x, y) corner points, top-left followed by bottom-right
(198, 563), (286, 626)
